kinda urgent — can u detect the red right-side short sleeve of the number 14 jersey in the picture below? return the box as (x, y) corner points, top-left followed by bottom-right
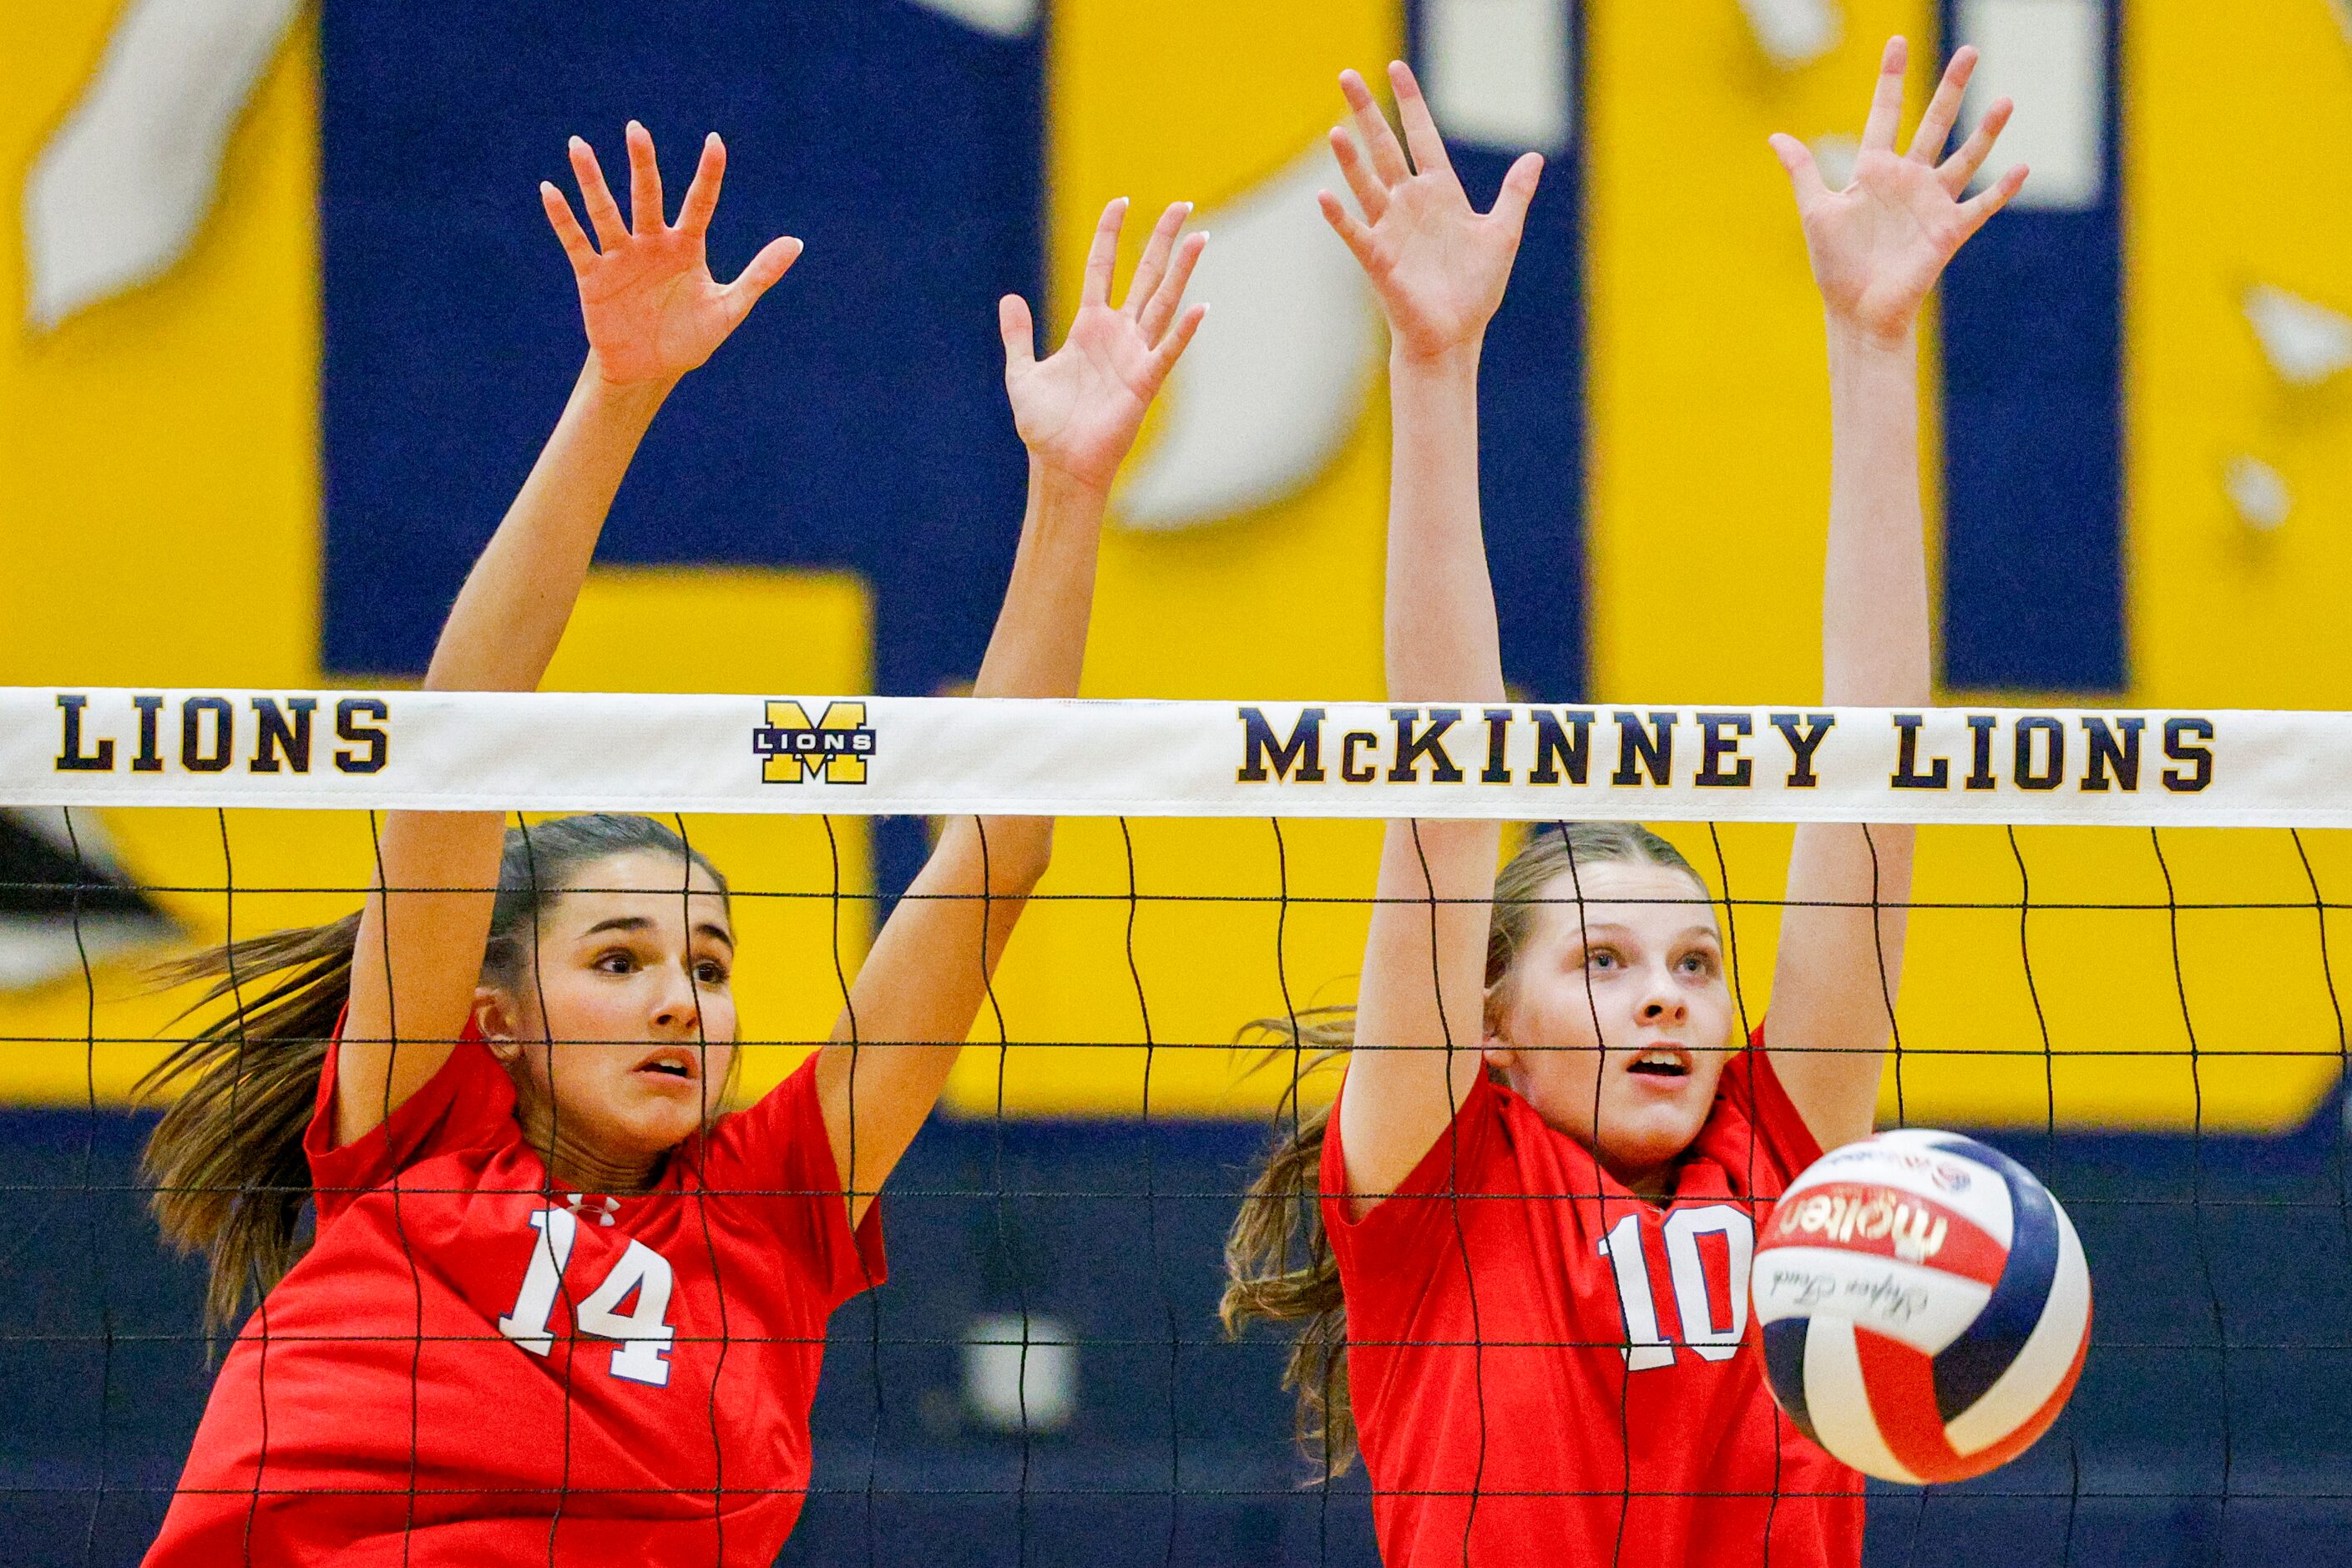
(703, 1055), (889, 1312)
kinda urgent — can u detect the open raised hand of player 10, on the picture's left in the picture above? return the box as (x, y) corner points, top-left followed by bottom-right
(1318, 61), (1543, 357)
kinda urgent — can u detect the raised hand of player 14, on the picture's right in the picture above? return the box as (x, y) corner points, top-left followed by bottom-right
(997, 195), (1209, 491)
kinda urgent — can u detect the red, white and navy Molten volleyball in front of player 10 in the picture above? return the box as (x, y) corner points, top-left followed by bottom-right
(1753, 1128), (2091, 1484)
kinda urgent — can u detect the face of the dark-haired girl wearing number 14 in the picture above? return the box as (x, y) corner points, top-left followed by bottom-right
(475, 851), (736, 1166)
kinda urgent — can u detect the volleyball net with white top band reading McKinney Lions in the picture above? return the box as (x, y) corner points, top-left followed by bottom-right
(0, 689), (2352, 1563)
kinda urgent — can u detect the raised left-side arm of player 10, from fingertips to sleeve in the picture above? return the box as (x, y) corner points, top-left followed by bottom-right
(1322, 63), (1543, 1213)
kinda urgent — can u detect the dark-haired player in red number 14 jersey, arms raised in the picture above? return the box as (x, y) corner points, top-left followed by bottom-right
(148, 124), (1204, 1568)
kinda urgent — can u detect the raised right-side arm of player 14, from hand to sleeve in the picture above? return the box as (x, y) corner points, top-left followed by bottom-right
(816, 198), (1209, 1225)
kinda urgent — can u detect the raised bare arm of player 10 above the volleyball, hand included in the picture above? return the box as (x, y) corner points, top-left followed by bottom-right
(1767, 38), (2025, 1147)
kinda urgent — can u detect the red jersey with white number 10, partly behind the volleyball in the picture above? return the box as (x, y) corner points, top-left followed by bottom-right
(1322, 1029), (1863, 1568)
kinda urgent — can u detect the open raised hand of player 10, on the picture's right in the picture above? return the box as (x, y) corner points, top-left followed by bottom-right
(1771, 38), (2025, 341)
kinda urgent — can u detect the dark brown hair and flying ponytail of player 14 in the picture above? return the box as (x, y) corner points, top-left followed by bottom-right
(134, 813), (726, 1331)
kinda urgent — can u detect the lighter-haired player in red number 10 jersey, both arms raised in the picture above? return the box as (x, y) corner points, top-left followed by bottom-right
(1226, 40), (2025, 1568)
